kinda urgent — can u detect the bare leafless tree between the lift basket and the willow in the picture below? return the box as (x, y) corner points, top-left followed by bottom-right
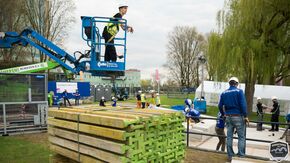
(165, 26), (205, 87)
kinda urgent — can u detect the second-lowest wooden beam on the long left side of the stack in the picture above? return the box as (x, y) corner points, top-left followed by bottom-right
(48, 136), (126, 163)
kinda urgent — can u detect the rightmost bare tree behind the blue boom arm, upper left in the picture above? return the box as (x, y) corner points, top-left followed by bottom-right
(25, 0), (75, 62)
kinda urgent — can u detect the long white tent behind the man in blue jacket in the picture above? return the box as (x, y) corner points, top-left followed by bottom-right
(195, 81), (290, 115)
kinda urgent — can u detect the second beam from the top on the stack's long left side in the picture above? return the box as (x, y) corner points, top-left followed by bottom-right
(47, 118), (126, 141)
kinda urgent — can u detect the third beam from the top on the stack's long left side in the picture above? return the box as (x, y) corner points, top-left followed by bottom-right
(48, 127), (126, 154)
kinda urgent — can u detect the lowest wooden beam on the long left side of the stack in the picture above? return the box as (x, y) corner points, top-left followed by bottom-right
(50, 144), (105, 163)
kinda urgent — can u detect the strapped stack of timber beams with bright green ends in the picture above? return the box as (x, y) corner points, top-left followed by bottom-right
(48, 108), (185, 163)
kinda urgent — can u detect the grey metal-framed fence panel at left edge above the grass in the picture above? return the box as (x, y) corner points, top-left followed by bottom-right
(0, 73), (48, 135)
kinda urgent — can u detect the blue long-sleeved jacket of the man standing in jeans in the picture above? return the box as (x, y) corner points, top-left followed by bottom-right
(219, 86), (247, 117)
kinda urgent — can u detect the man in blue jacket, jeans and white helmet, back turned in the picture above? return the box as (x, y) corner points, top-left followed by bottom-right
(218, 77), (249, 161)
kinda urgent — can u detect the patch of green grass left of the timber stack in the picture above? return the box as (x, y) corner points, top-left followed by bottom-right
(0, 137), (52, 163)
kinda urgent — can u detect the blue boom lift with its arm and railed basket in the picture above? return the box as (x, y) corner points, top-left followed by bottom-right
(0, 16), (127, 79)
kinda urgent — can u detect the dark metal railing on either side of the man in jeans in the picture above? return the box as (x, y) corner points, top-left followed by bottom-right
(184, 117), (290, 160)
